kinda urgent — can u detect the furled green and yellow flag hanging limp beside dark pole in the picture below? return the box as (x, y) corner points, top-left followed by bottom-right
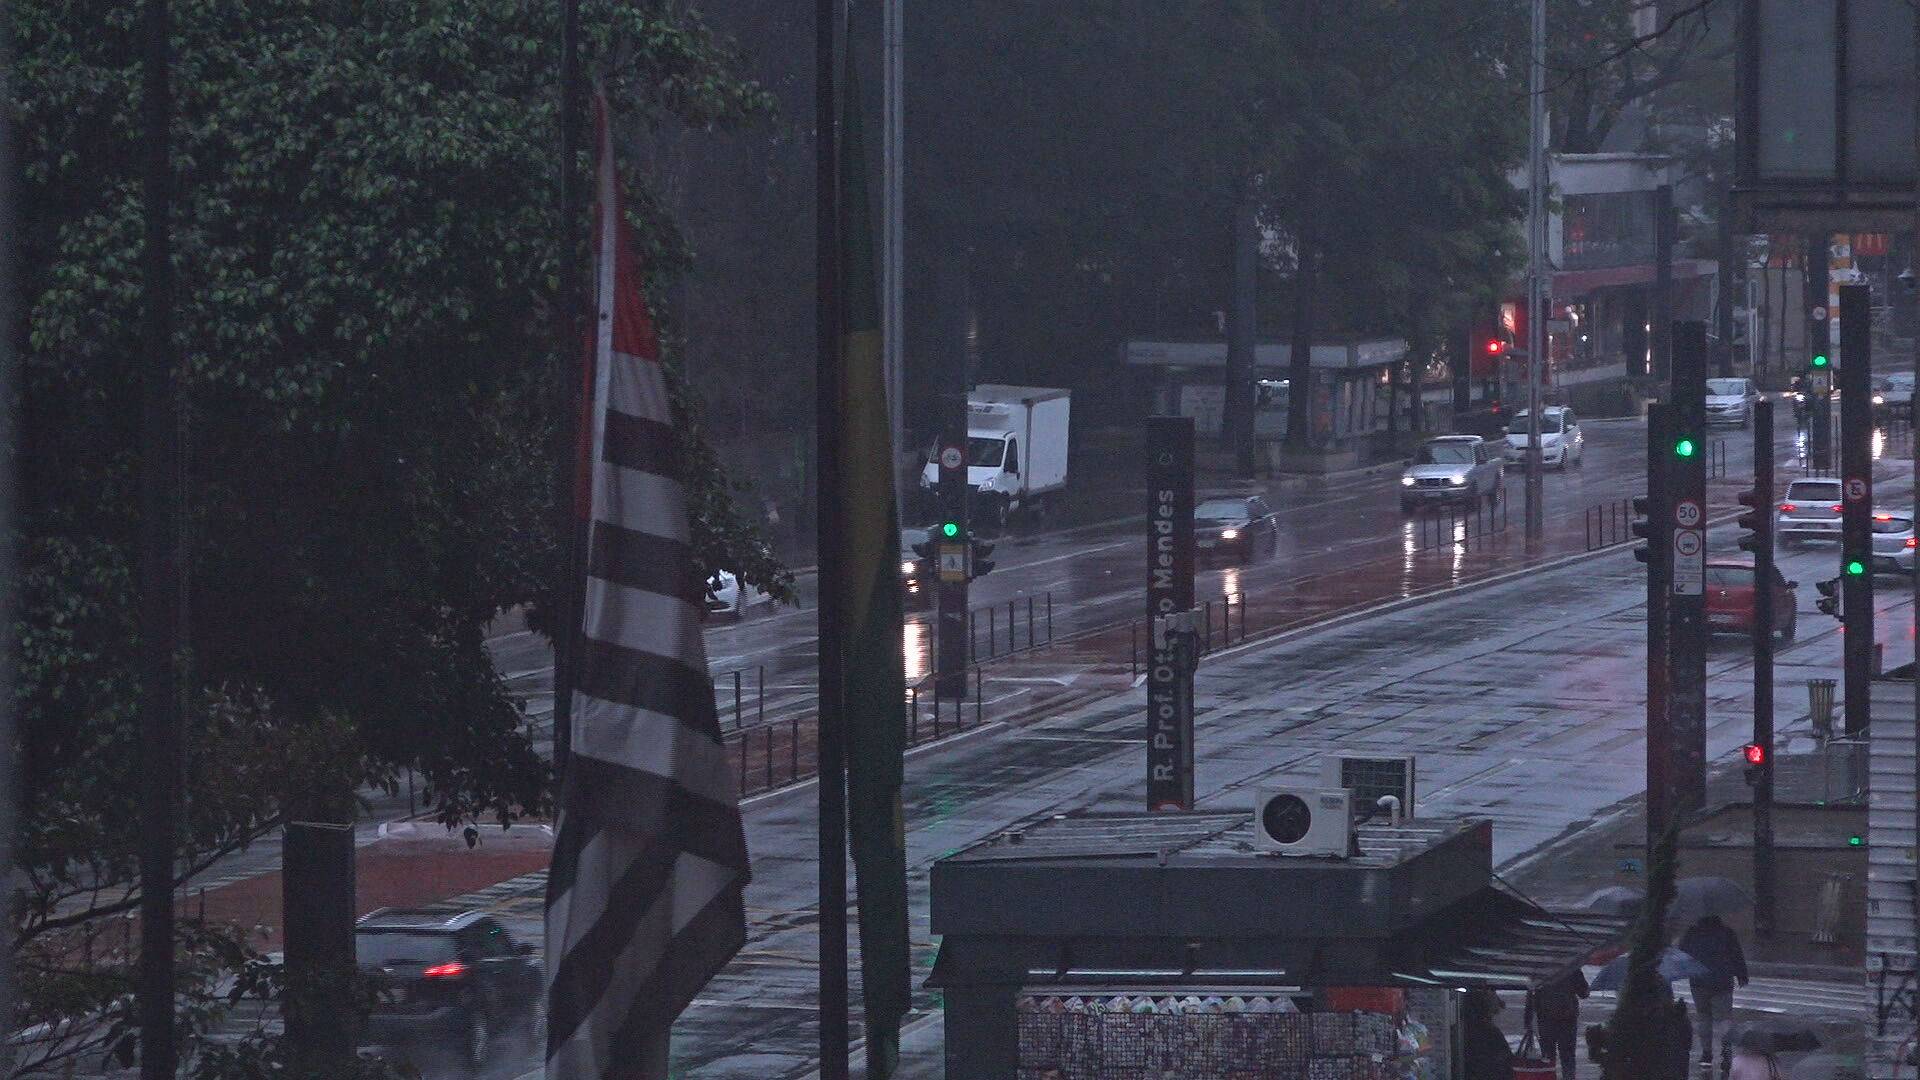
(822, 42), (910, 1080)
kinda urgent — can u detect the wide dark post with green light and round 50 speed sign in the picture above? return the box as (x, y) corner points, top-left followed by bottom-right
(1667, 321), (1707, 813)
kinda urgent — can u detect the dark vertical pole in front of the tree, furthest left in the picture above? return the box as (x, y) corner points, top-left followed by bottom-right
(134, 0), (184, 1080)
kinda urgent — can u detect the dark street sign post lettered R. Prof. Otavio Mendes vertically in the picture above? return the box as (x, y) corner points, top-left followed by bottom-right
(1146, 417), (1198, 811)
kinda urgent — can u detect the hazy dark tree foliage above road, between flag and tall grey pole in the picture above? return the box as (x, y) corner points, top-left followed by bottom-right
(908, 0), (1524, 424)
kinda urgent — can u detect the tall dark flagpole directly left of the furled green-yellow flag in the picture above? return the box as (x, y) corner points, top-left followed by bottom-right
(814, 0), (849, 1080)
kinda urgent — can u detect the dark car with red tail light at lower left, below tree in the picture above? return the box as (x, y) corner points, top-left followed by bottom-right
(353, 907), (543, 1072)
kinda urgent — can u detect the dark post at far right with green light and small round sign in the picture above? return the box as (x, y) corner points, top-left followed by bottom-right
(1836, 284), (1874, 736)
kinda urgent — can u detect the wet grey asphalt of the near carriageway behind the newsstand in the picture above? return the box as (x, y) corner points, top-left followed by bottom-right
(483, 413), (1914, 1080)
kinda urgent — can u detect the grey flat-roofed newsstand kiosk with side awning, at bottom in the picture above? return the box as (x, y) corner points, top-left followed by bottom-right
(927, 813), (1626, 1080)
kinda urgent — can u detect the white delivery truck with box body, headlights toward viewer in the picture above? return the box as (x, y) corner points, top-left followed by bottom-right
(920, 382), (1073, 525)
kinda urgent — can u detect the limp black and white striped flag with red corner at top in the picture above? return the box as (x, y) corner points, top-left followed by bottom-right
(547, 96), (747, 1080)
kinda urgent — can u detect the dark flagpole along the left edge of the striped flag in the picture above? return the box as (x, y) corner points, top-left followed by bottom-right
(553, 0), (586, 768)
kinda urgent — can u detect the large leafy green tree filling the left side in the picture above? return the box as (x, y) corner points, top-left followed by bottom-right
(10, 0), (787, 1070)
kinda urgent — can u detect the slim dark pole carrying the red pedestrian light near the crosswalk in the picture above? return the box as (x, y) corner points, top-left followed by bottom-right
(1740, 402), (1780, 938)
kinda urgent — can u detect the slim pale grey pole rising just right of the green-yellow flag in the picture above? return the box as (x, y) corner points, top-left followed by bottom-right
(879, 0), (906, 505)
